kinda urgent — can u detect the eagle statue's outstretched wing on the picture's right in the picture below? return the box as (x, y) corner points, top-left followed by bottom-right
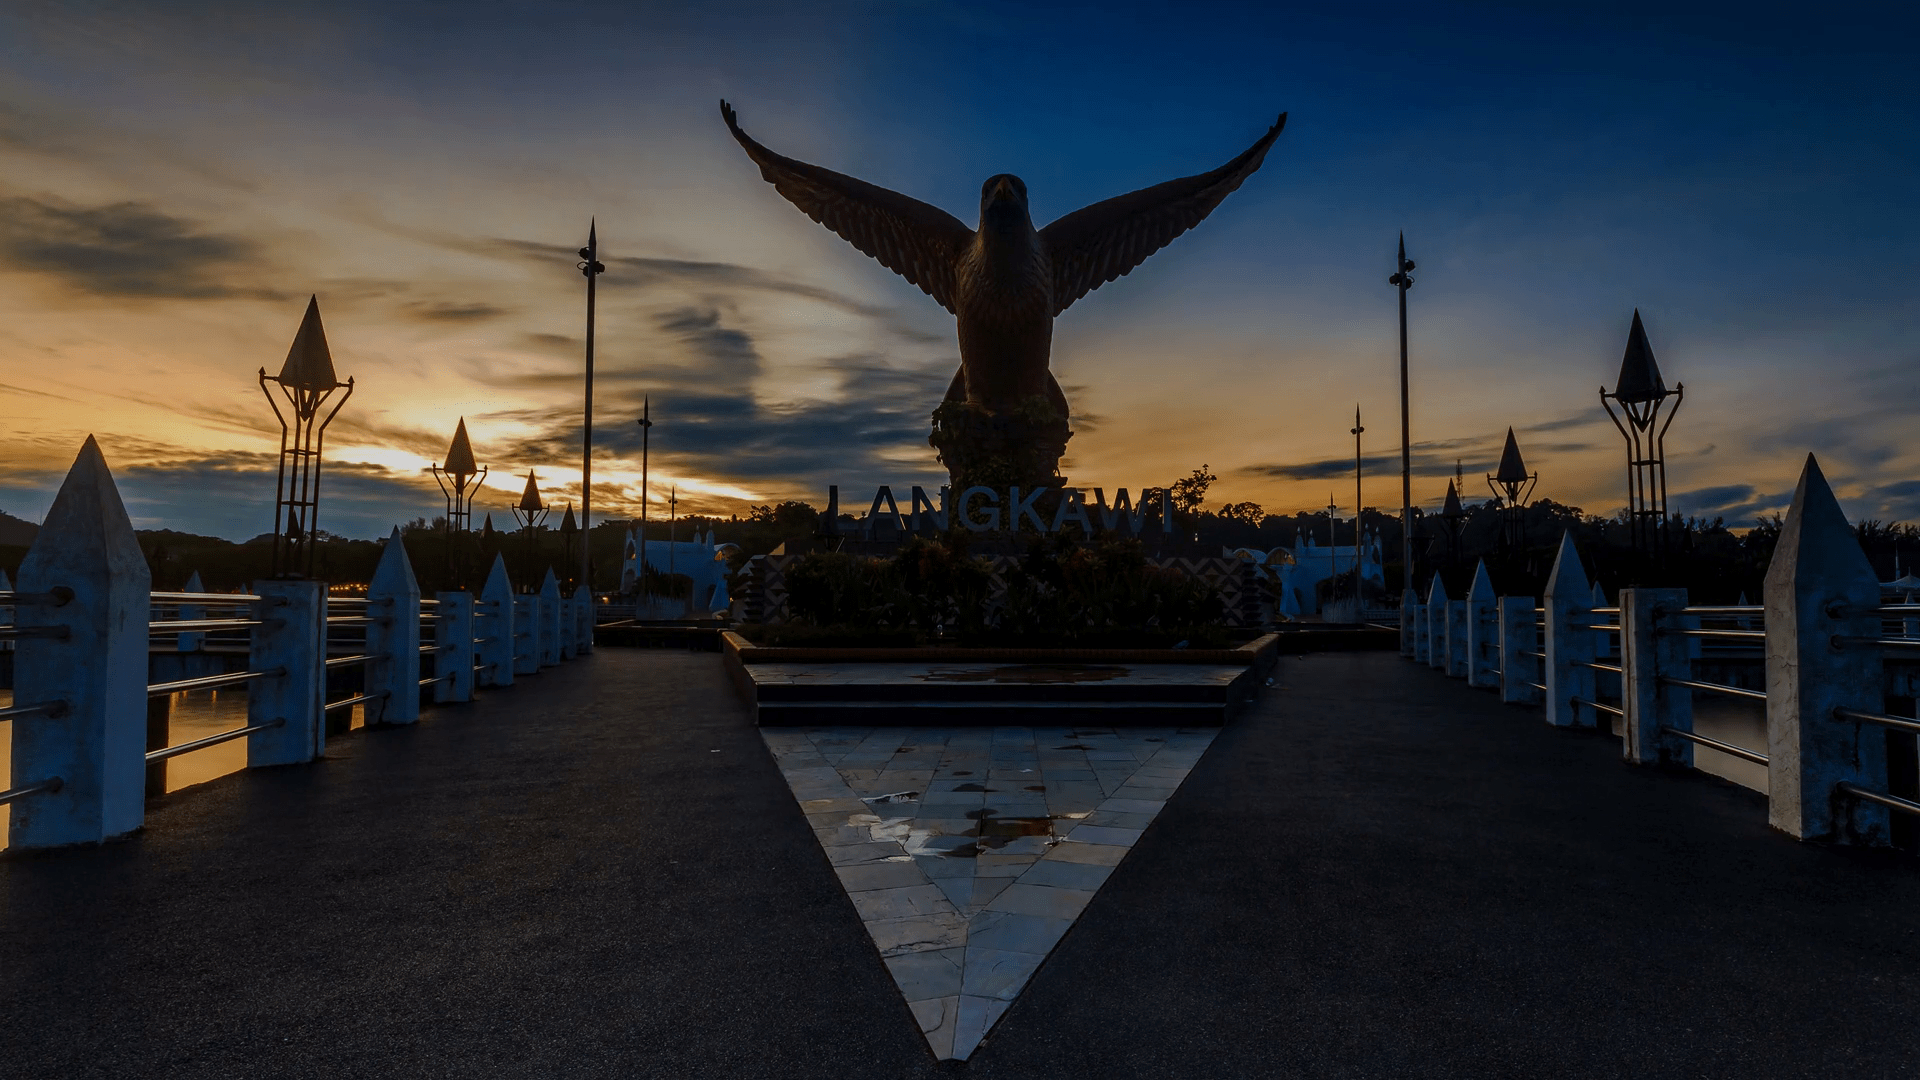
(1041, 113), (1286, 315)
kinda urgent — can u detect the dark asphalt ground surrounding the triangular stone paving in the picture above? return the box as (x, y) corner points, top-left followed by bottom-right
(0, 650), (1920, 1078)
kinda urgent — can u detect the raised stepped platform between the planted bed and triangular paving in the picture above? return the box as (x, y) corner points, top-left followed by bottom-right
(720, 632), (1279, 726)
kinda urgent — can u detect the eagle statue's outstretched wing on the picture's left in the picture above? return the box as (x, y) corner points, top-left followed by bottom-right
(720, 102), (973, 311)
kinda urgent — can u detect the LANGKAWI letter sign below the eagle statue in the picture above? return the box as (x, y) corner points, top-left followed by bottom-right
(828, 484), (1173, 536)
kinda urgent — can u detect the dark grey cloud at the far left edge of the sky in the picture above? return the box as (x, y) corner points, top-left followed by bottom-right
(0, 196), (278, 300)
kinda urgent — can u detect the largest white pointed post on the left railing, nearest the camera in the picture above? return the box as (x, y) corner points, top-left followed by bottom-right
(8, 436), (154, 849)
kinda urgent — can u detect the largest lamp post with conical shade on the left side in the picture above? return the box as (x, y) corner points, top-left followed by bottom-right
(259, 296), (353, 578)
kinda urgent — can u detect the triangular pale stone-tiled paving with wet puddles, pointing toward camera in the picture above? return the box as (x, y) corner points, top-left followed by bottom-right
(762, 726), (1217, 1061)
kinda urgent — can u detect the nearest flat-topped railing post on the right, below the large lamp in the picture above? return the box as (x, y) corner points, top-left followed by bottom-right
(1620, 588), (1693, 767)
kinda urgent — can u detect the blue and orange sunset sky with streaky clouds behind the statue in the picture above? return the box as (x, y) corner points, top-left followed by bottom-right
(0, 0), (1920, 540)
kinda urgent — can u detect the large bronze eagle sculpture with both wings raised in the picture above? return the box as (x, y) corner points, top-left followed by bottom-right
(720, 102), (1286, 423)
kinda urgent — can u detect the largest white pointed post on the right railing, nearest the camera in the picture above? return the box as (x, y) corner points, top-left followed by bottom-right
(1766, 454), (1887, 844)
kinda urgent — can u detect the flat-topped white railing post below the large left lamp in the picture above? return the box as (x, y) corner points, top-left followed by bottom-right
(246, 580), (326, 767)
